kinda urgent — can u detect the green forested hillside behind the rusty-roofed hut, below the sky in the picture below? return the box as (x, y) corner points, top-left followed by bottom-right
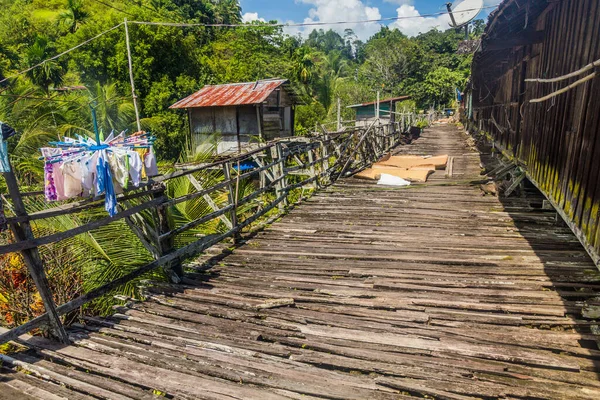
(0, 0), (484, 161)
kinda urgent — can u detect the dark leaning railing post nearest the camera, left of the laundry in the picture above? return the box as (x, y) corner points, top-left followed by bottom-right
(4, 166), (70, 344)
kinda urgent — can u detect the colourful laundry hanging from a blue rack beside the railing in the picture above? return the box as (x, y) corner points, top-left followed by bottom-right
(40, 132), (158, 217)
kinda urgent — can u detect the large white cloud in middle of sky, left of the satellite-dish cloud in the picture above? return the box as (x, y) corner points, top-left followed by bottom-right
(288, 0), (381, 40)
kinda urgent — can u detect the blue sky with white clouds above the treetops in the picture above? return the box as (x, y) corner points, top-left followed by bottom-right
(240, 0), (499, 40)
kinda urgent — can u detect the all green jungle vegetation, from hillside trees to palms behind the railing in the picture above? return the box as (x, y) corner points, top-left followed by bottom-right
(0, 0), (483, 332)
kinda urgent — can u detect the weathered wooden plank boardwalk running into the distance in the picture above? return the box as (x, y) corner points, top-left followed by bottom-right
(0, 125), (600, 400)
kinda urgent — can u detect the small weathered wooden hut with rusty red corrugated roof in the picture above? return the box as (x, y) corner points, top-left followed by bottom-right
(170, 79), (298, 154)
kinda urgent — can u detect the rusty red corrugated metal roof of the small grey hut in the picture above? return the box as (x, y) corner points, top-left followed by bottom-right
(169, 79), (288, 108)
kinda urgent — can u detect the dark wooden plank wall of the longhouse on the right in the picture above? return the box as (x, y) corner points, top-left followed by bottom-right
(469, 0), (600, 264)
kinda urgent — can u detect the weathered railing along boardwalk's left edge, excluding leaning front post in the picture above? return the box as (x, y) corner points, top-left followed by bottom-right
(0, 114), (417, 344)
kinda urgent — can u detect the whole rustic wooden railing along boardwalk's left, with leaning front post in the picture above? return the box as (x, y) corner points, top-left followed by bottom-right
(0, 115), (418, 344)
